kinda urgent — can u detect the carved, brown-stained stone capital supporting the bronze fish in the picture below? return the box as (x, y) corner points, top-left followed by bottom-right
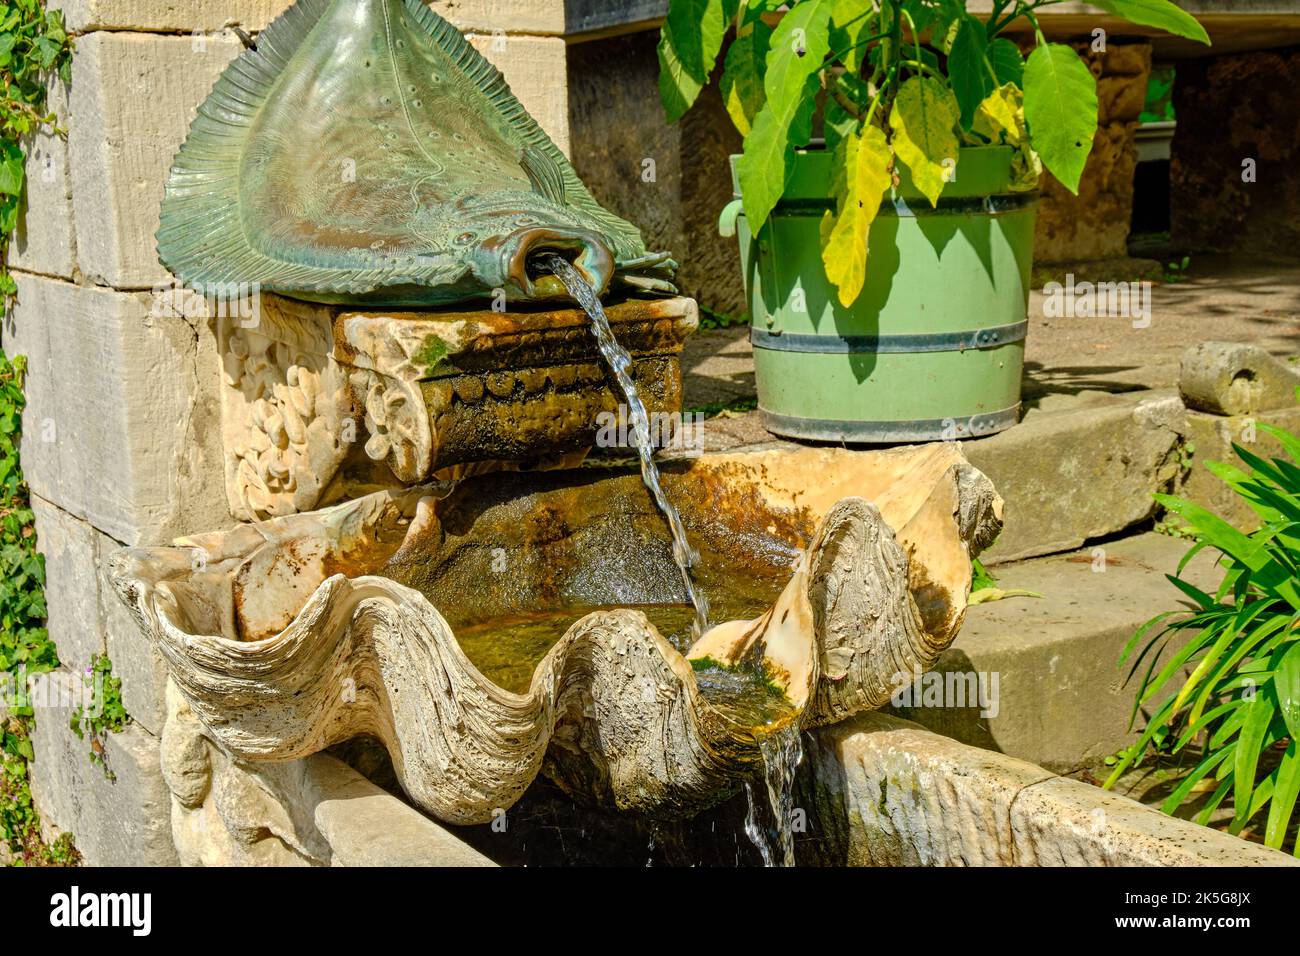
(217, 295), (697, 520)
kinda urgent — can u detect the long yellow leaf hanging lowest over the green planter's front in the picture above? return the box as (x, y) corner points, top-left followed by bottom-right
(822, 126), (893, 307)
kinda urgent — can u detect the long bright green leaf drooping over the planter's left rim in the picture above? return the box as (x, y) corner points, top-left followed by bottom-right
(736, 0), (832, 234)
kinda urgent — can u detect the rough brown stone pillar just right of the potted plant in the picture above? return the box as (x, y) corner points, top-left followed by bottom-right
(1034, 43), (1151, 263)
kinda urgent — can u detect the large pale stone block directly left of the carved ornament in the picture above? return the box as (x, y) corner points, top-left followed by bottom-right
(4, 273), (230, 544)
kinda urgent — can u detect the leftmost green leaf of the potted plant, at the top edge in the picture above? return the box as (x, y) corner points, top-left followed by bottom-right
(659, 0), (740, 122)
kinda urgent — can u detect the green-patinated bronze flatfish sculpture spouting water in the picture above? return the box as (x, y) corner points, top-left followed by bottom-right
(157, 0), (675, 306)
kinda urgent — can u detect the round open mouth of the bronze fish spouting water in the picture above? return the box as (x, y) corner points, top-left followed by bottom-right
(485, 226), (614, 299)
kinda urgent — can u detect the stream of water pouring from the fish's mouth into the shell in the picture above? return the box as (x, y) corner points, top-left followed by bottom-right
(541, 255), (709, 639)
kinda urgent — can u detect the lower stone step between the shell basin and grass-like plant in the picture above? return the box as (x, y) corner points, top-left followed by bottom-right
(898, 533), (1221, 773)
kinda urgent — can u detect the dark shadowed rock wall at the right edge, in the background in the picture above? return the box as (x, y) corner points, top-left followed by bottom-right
(1170, 47), (1300, 256)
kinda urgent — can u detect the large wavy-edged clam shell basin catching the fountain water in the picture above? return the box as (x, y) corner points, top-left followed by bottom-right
(113, 445), (1001, 823)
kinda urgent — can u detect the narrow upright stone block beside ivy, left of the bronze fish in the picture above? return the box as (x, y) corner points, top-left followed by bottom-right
(9, 81), (75, 278)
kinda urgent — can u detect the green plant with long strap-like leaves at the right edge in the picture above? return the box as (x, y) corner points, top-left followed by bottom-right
(1105, 424), (1300, 849)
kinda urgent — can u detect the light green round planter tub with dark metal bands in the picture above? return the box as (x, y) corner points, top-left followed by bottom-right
(719, 147), (1037, 442)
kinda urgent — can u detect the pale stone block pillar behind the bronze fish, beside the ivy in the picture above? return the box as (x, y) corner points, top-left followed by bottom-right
(3, 0), (569, 865)
